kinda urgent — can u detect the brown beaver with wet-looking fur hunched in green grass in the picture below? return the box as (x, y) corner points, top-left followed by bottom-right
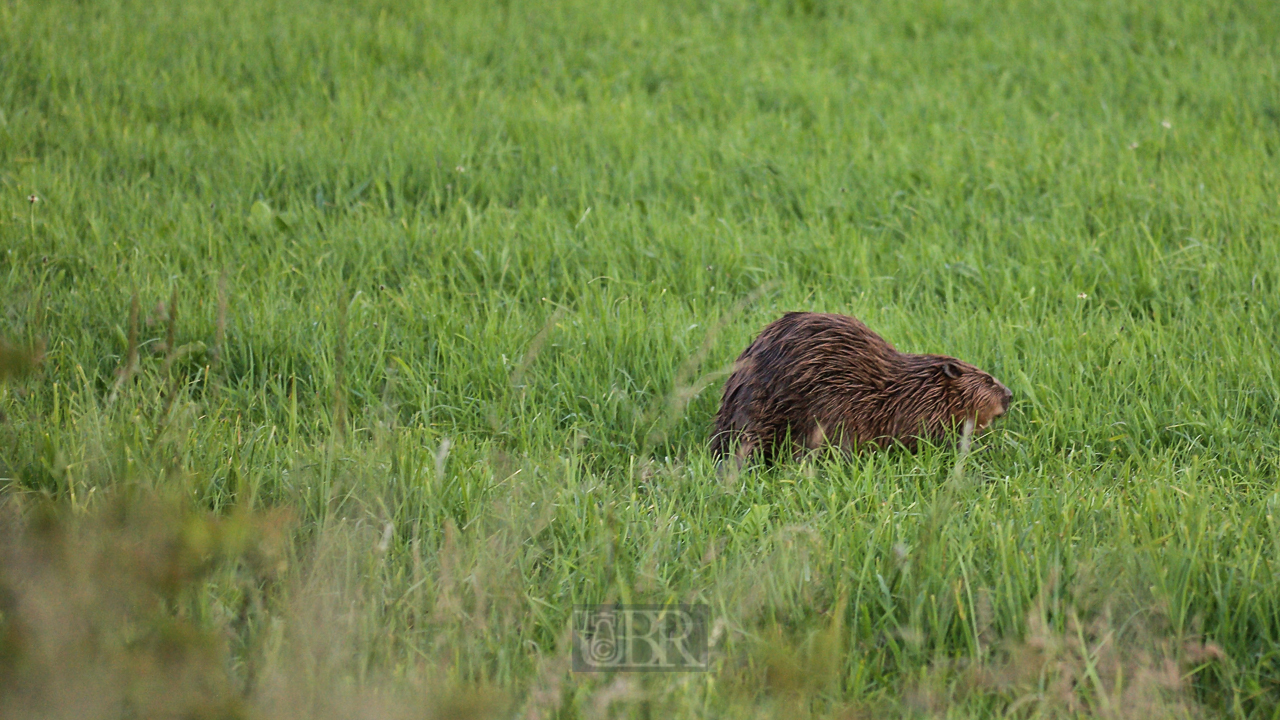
(710, 313), (1012, 461)
